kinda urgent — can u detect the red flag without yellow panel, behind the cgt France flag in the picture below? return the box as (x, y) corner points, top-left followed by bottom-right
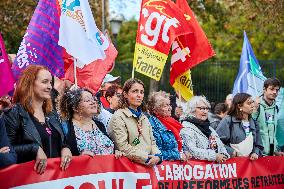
(170, 0), (215, 85)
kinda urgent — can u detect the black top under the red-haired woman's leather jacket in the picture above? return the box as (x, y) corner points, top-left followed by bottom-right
(30, 114), (61, 158)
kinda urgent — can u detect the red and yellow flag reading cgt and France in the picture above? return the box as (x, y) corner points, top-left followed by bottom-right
(133, 0), (191, 81)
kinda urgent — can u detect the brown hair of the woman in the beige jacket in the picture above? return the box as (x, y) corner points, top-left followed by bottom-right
(120, 78), (146, 111)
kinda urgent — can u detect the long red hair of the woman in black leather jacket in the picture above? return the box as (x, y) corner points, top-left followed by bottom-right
(13, 65), (52, 114)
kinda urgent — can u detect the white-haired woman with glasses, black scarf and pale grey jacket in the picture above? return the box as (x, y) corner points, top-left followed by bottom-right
(180, 96), (230, 163)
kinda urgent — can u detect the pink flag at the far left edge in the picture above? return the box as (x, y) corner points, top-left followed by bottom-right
(0, 34), (15, 97)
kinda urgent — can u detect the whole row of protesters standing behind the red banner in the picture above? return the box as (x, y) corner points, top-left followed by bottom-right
(0, 65), (284, 174)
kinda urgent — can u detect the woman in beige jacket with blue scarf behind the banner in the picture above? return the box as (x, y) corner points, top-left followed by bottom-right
(108, 79), (162, 166)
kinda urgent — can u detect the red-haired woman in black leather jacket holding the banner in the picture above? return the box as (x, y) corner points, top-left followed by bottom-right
(4, 65), (72, 174)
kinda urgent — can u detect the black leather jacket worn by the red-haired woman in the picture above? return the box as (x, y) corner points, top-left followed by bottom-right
(3, 104), (66, 163)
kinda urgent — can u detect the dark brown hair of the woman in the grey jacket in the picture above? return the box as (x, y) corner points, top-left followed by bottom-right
(228, 93), (251, 120)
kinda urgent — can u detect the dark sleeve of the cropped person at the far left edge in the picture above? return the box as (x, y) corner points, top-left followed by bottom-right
(0, 116), (17, 168)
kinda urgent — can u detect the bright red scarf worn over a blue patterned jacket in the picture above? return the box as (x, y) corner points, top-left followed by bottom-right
(156, 115), (183, 151)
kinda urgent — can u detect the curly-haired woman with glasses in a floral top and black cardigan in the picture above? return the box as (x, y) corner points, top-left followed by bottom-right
(59, 88), (114, 156)
